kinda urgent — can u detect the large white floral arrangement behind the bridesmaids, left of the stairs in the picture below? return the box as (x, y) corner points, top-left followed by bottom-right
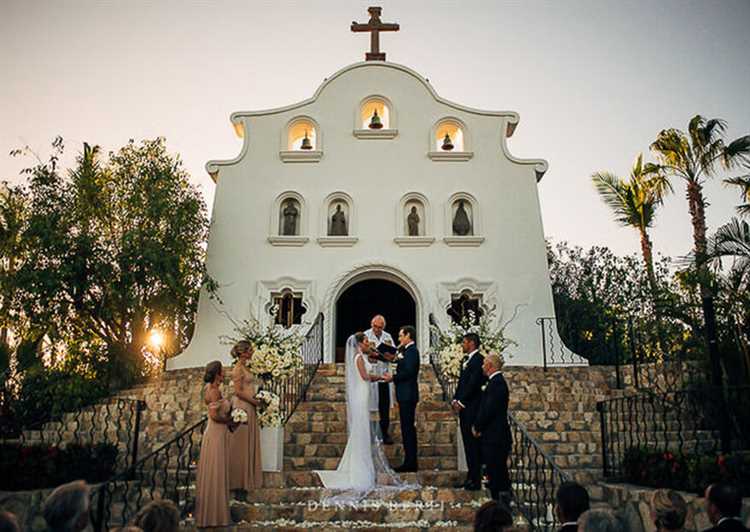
(225, 308), (304, 381)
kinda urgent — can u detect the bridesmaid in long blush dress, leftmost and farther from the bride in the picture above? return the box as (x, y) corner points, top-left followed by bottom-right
(195, 360), (233, 528)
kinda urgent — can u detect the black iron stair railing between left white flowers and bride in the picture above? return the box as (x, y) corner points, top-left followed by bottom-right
(267, 313), (324, 424)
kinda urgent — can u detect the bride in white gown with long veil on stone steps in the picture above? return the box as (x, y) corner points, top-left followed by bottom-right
(316, 332), (412, 492)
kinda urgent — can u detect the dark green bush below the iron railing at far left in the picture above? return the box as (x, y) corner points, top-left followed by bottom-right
(0, 443), (118, 491)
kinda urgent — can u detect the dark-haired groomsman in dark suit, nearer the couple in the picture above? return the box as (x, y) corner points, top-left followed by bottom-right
(451, 333), (487, 491)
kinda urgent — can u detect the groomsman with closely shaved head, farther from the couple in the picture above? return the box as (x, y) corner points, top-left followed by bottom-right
(472, 353), (513, 503)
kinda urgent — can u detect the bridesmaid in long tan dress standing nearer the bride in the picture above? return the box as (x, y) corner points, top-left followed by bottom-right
(229, 340), (263, 491)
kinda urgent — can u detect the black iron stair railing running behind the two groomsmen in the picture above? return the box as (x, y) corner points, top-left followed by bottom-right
(430, 344), (569, 532)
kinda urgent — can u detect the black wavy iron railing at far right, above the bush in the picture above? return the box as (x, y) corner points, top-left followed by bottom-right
(597, 386), (750, 481)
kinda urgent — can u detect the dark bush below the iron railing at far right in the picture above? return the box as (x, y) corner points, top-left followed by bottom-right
(622, 447), (750, 497)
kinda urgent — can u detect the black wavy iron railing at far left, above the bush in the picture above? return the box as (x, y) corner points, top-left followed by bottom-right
(0, 373), (146, 472)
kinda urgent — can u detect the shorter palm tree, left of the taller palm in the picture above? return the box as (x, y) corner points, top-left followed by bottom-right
(591, 154), (672, 306)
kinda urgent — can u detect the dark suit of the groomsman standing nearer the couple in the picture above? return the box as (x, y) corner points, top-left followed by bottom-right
(453, 351), (487, 485)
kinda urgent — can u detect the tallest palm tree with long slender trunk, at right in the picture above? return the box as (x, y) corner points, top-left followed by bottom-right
(651, 115), (750, 384)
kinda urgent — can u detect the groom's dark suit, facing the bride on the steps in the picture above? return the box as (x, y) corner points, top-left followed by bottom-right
(393, 344), (419, 469)
